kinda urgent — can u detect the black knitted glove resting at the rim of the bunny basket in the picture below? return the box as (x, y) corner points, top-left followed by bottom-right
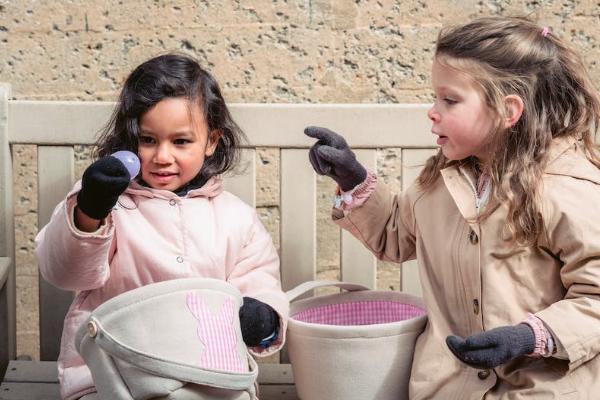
(240, 297), (279, 347)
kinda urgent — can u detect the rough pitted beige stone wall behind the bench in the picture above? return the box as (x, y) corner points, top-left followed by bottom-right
(0, 0), (600, 358)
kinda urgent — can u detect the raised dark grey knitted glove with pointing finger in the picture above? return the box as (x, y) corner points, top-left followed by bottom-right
(304, 126), (367, 192)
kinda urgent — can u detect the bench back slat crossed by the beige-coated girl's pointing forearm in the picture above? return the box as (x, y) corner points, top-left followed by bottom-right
(341, 149), (377, 289)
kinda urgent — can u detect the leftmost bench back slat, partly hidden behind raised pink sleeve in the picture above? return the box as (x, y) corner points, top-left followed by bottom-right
(38, 146), (74, 361)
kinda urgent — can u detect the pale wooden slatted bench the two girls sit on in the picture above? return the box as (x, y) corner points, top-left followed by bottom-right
(0, 84), (434, 400)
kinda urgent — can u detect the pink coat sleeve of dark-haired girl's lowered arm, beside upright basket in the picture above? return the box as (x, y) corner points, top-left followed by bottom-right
(227, 211), (289, 357)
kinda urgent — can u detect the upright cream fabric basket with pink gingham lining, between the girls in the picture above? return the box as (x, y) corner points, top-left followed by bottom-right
(287, 281), (427, 400)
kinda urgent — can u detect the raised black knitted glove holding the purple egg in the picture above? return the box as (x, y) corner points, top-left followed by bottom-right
(77, 156), (130, 220)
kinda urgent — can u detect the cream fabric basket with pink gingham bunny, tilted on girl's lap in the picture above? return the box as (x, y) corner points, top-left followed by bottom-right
(75, 278), (258, 400)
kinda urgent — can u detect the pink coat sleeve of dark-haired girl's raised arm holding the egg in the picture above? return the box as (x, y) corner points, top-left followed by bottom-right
(35, 185), (114, 290)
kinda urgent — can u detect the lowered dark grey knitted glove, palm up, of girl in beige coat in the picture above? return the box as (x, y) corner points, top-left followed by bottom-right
(446, 324), (535, 368)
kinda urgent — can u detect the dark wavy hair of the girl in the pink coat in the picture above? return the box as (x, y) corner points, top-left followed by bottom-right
(93, 53), (246, 181)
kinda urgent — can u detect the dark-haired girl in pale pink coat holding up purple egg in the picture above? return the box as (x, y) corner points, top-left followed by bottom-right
(36, 54), (288, 399)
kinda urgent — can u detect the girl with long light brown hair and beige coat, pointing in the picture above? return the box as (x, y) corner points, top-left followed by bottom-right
(305, 17), (600, 400)
